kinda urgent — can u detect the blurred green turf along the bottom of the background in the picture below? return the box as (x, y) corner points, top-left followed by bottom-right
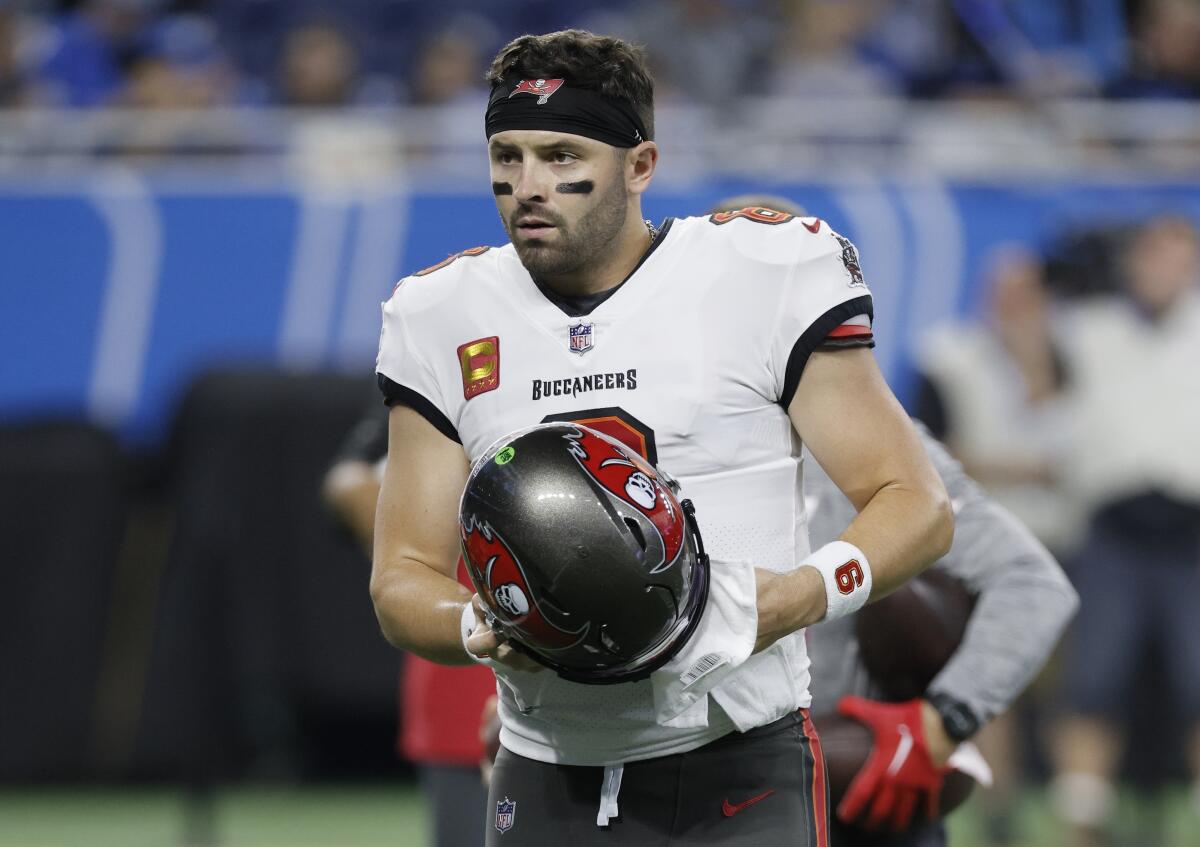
(0, 783), (1200, 847)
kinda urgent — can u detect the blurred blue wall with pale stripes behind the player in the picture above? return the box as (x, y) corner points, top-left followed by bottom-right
(9, 172), (1200, 449)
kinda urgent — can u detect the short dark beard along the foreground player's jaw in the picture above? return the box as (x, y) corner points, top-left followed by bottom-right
(504, 179), (629, 277)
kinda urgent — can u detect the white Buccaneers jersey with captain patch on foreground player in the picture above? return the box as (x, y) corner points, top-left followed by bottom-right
(377, 210), (871, 765)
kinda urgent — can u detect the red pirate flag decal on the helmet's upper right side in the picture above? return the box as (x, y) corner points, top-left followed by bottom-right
(565, 427), (684, 573)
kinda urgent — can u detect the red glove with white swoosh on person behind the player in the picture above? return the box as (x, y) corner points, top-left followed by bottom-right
(838, 697), (949, 833)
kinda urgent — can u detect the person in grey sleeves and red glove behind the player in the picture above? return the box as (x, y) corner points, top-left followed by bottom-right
(712, 194), (1079, 847)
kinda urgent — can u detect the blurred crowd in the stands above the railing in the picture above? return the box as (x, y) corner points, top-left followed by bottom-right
(7, 0), (1200, 109)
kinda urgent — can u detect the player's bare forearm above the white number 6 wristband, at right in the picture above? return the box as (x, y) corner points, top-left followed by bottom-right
(841, 477), (954, 602)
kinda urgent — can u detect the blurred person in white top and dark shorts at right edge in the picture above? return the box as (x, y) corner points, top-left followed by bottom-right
(1052, 217), (1200, 845)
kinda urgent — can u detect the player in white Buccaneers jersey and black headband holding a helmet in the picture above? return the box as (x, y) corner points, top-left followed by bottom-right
(371, 30), (953, 846)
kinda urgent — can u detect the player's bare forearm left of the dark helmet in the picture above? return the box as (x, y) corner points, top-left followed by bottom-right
(371, 561), (472, 665)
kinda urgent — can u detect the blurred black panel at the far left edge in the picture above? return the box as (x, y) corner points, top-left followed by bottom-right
(0, 424), (128, 781)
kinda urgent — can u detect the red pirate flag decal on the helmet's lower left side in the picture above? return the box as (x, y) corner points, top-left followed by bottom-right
(458, 517), (588, 650)
